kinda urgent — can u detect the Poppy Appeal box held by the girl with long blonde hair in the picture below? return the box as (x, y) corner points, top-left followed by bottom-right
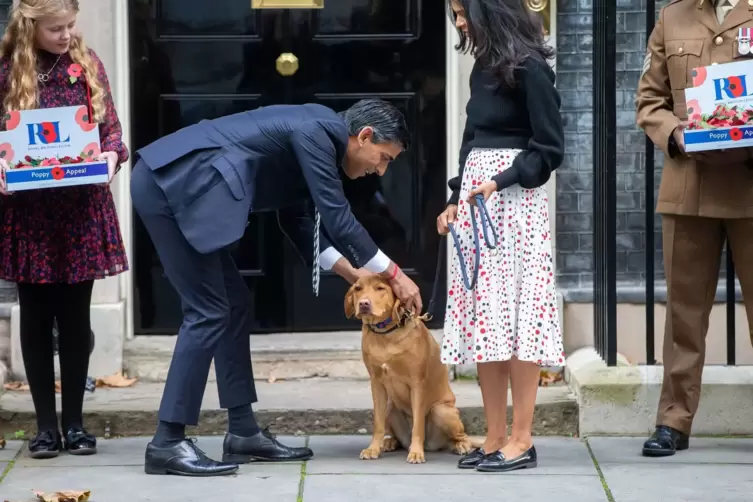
(0, 105), (109, 192)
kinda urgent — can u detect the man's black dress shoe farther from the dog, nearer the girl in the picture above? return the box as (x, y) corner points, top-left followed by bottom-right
(144, 439), (238, 477)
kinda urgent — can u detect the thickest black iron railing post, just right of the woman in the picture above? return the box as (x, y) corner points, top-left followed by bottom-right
(593, 0), (617, 366)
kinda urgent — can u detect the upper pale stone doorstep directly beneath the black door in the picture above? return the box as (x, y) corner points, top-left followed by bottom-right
(123, 331), (369, 382)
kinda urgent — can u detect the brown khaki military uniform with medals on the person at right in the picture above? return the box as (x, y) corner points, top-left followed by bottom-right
(636, 0), (753, 434)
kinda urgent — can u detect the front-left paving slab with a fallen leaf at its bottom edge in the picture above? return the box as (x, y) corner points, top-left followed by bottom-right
(0, 464), (301, 502)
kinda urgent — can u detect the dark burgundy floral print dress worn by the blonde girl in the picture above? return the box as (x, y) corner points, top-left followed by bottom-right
(0, 50), (129, 284)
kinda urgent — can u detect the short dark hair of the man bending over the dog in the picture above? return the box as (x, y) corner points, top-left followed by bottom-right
(340, 99), (411, 150)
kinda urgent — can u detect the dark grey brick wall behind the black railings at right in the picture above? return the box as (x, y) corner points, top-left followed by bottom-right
(557, 0), (666, 301)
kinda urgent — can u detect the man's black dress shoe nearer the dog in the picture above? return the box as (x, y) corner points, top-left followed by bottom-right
(222, 429), (314, 464)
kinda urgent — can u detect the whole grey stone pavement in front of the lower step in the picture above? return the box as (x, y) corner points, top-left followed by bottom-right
(0, 435), (753, 502)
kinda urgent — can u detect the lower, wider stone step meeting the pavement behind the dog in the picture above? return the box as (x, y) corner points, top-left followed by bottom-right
(0, 378), (578, 437)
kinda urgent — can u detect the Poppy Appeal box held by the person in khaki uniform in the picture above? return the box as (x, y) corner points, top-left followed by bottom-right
(683, 60), (753, 152)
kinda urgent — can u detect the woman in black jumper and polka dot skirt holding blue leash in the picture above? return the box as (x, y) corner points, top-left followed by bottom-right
(437, 0), (564, 472)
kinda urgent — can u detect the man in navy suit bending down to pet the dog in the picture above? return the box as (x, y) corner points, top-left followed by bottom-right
(131, 100), (422, 476)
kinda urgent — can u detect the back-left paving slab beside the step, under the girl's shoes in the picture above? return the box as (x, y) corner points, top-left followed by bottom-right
(16, 436), (306, 468)
